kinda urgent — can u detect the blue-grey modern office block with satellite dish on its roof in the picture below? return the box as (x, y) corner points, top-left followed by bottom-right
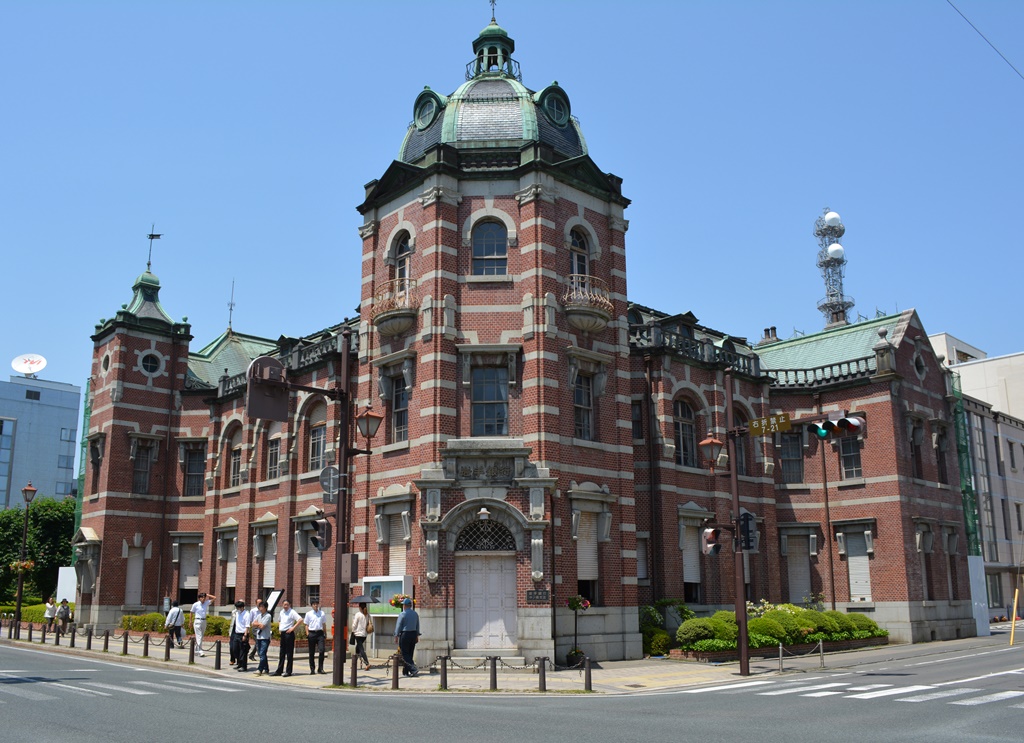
(0, 377), (82, 509)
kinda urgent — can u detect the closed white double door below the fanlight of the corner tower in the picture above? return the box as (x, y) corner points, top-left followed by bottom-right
(455, 553), (516, 650)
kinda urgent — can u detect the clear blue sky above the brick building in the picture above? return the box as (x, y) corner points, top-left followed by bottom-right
(0, 0), (1024, 395)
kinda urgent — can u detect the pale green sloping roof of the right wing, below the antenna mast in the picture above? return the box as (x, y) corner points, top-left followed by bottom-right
(758, 309), (921, 373)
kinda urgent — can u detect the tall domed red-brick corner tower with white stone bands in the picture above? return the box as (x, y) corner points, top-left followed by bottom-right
(353, 19), (640, 658)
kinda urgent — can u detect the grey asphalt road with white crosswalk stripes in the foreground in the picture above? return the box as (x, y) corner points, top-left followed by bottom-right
(0, 644), (1024, 743)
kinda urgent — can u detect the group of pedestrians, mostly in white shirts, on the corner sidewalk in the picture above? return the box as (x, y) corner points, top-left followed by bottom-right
(156, 594), (420, 676)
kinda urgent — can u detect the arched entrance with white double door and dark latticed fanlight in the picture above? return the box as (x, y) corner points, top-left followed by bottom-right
(455, 520), (517, 650)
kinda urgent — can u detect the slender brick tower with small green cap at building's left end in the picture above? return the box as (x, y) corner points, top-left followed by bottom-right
(75, 266), (193, 625)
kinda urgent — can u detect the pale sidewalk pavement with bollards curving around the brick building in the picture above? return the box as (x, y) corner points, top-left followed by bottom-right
(0, 626), (1008, 694)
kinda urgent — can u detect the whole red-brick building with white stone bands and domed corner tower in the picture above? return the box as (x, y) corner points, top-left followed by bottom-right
(76, 23), (973, 660)
